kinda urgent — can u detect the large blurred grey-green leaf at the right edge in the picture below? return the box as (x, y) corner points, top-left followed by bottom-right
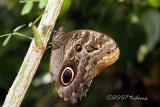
(140, 9), (160, 51)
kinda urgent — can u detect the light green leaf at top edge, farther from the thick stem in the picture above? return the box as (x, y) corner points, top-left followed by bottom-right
(21, 0), (33, 15)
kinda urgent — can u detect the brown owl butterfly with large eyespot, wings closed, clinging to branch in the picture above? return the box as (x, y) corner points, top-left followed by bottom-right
(50, 28), (120, 103)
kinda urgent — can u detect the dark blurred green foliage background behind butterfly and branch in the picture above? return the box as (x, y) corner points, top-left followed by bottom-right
(0, 0), (160, 107)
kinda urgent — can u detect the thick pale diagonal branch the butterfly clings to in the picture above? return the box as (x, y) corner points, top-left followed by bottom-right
(3, 0), (63, 107)
